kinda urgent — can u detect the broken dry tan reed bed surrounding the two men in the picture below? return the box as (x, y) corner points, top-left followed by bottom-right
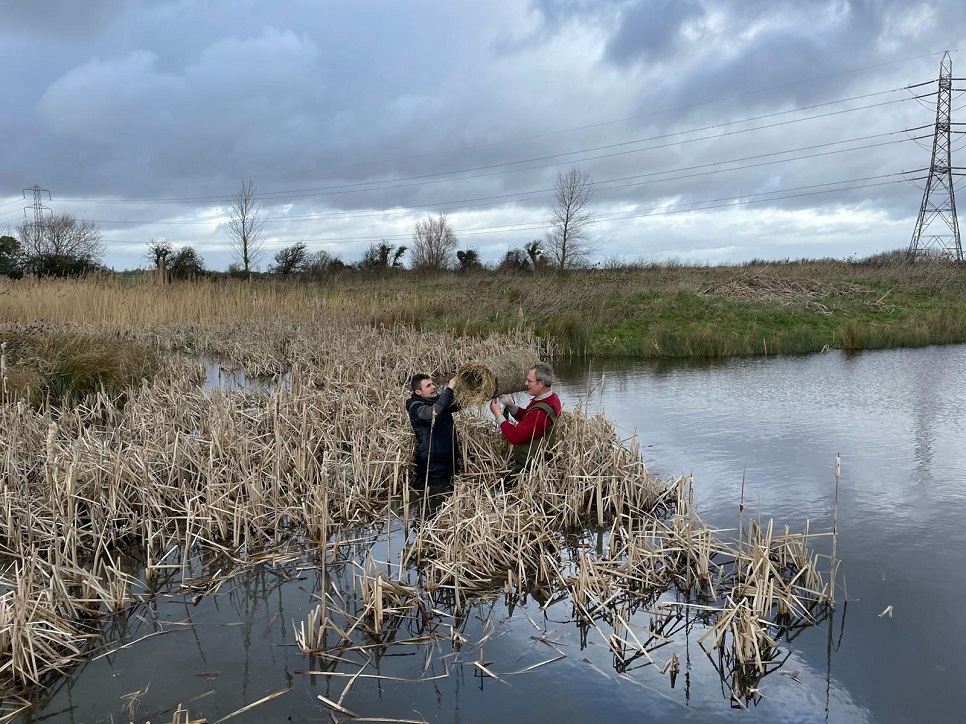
(0, 319), (830, 713)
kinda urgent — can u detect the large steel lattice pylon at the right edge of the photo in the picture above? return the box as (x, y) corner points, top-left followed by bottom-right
(909, 51), (963, 261)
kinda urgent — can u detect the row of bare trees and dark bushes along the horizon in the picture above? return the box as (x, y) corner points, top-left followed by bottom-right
(0, 167), (597, 280)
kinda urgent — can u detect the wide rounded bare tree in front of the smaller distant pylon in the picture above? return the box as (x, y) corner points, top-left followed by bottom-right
(17, 214), (104, 276)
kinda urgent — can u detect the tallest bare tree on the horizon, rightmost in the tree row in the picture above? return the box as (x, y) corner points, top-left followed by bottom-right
(546, 166), (598, 269)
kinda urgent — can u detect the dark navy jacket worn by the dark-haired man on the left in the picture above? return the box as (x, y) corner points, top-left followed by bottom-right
(406, 387), (460, 481)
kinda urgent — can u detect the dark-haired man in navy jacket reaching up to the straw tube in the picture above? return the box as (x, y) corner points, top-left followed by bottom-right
(406, 374), (460, 492)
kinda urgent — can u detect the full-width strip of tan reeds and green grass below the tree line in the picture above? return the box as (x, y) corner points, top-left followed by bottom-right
(0, 261), (966, 357)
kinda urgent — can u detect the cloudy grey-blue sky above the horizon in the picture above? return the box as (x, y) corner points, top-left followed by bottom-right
(0, 0), (966, 270)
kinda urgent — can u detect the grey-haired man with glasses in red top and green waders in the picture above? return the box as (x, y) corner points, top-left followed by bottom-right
(490, 363), (560, 483)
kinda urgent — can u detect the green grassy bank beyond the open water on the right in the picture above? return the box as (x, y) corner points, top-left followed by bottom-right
(376, 261), (966, 357)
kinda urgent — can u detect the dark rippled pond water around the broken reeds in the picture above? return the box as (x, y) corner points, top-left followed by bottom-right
(22, 346), (966, 724)
